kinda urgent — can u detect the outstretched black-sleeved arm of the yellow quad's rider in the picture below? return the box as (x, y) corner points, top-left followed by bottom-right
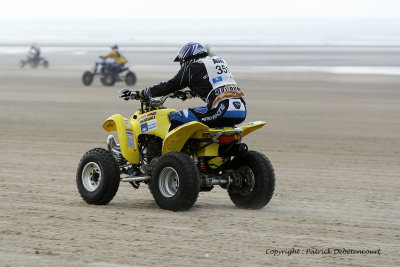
(141, 65), (199, 97)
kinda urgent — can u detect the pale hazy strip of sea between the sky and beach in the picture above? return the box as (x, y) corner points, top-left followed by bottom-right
(0, 17), (400, 46)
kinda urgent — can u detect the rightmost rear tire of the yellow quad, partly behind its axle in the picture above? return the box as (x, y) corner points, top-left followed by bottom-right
(228, 151), (275, 209)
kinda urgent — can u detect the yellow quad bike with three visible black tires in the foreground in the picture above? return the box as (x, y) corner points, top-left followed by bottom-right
(76, 91), (275, 211)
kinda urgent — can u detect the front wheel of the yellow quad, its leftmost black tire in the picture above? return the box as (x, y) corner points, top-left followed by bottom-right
(76, 148), (120, 205)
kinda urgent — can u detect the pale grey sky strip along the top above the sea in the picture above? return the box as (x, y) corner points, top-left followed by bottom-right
(0, 0), (400, 19)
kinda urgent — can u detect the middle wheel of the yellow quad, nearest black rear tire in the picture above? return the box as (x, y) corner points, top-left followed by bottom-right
(149, 152), (200, 211)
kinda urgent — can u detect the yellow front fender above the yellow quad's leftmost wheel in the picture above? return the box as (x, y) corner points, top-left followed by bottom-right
(103, 114), (139, 164)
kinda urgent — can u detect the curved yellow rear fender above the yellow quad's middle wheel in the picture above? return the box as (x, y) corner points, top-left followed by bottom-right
(162, 121), (209, 154)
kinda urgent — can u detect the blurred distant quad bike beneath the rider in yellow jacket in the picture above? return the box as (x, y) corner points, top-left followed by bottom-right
(82, 60), (136, 86)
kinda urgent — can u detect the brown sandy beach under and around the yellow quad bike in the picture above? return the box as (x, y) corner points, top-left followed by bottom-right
(0, 52), (400, 267)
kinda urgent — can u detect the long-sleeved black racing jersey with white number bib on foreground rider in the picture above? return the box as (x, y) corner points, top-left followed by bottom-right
(143, 57), (244, 108)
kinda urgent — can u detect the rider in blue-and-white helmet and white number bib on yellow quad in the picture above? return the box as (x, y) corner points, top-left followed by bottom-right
(120, 42), (247, 130)
